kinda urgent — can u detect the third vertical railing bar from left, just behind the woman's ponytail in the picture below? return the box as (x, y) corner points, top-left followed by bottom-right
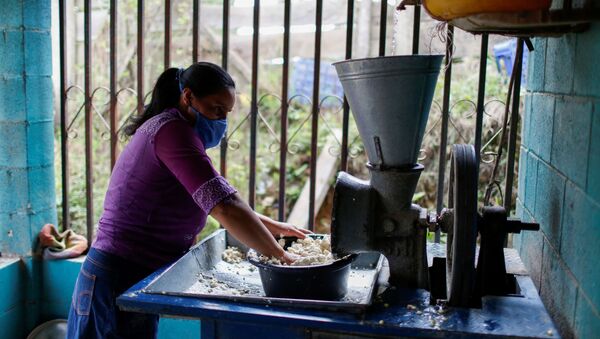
(110, 0), (118, 170)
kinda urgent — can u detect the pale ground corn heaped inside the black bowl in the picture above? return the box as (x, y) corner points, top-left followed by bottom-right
(259, 237), (335, 266)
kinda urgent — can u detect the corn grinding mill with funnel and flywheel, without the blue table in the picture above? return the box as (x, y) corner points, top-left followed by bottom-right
(332, 55), (539, 307)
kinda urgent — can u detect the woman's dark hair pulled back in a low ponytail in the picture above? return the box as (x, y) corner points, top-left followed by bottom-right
(123, 62), (235, 136)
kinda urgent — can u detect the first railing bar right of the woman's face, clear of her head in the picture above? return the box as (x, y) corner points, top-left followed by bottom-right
(248, 0), (260, 208)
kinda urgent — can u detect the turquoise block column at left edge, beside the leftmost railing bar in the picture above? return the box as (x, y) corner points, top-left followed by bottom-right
(0, 0), (56, 256)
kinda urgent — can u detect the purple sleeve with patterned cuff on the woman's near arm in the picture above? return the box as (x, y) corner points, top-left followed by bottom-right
(154, 121), (237, 214)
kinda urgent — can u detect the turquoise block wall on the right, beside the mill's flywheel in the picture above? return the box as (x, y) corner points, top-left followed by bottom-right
(515, 24), (600, 338)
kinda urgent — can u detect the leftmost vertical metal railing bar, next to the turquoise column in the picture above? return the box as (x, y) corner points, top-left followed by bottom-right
(58, 0), (71, 230)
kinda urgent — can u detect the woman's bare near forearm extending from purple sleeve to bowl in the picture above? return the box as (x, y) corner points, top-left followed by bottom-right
(210, 193), (296, 263)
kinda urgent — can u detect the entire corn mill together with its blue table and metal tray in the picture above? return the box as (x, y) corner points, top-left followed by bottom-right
(117, 55), (557, 338)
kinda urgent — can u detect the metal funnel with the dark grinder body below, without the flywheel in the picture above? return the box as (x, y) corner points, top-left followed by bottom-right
(331, 55), (443, 288)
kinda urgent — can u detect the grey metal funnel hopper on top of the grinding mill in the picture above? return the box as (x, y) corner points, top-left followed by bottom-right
(334, 55), (443, 169)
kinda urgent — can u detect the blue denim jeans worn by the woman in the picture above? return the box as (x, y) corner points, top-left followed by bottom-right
(67, 248), (158, 338)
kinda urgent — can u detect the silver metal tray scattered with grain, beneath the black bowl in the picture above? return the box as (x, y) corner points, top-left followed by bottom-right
(143, 230), (384, 313)
